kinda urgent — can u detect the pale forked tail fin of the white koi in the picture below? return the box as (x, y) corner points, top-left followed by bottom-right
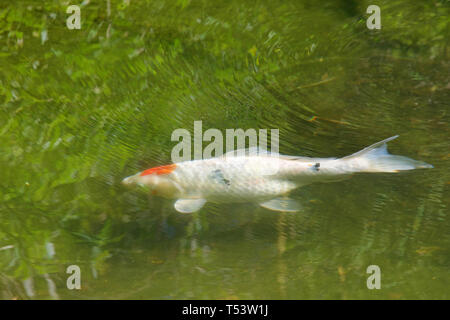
(342, 135), (433, 172)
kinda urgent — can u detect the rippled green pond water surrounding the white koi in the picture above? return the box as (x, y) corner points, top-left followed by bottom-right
(0, 0), (450, 299)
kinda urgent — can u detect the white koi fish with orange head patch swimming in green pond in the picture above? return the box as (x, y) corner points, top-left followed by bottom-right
(122, 136), (433, 213)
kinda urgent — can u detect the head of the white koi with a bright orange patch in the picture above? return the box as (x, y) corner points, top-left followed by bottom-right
(122, 165), (179, 198)
